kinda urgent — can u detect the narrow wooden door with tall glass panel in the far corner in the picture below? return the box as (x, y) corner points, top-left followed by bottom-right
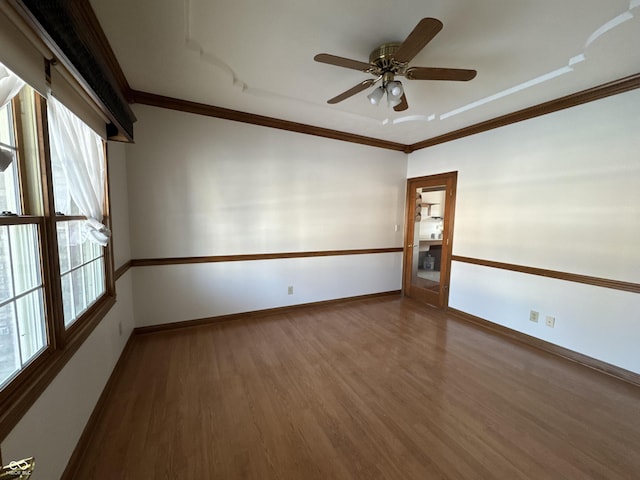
(403, 172), (458, 309)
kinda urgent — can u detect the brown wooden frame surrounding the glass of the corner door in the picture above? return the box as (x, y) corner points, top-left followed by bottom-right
(402, 171), (458, 310)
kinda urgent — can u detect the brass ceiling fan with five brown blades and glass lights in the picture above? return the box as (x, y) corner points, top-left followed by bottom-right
(313, 18), (477, 112)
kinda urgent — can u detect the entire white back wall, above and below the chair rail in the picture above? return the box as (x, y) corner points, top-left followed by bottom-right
(127, 105), (406, 325)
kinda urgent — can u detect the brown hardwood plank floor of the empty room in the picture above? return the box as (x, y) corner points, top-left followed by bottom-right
(75, 296), (640, 480)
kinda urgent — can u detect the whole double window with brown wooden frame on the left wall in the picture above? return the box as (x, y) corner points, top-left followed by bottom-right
(0, 63), (115, 438)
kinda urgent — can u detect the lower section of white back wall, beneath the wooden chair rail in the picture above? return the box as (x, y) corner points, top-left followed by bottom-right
(133, 253), (402, 327)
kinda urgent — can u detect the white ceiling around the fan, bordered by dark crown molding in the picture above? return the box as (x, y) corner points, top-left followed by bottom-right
(91, 0), (640, 144)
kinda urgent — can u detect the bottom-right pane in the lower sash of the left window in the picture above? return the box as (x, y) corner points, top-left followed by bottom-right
(16, 288), (47, 365)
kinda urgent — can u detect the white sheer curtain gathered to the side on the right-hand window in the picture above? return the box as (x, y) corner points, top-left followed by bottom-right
(47, 97), (111, 247)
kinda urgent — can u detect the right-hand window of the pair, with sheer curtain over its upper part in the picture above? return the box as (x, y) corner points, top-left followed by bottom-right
(48, 99), (110, 327)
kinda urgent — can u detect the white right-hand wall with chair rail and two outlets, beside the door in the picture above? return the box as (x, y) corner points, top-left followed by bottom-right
(408, 90), (640, 373)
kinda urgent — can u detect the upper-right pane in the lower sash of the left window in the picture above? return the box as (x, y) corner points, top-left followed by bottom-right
(9, 225), (42, 295)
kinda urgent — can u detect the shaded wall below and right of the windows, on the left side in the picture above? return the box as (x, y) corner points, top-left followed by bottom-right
(1, 144), (134, 480)
